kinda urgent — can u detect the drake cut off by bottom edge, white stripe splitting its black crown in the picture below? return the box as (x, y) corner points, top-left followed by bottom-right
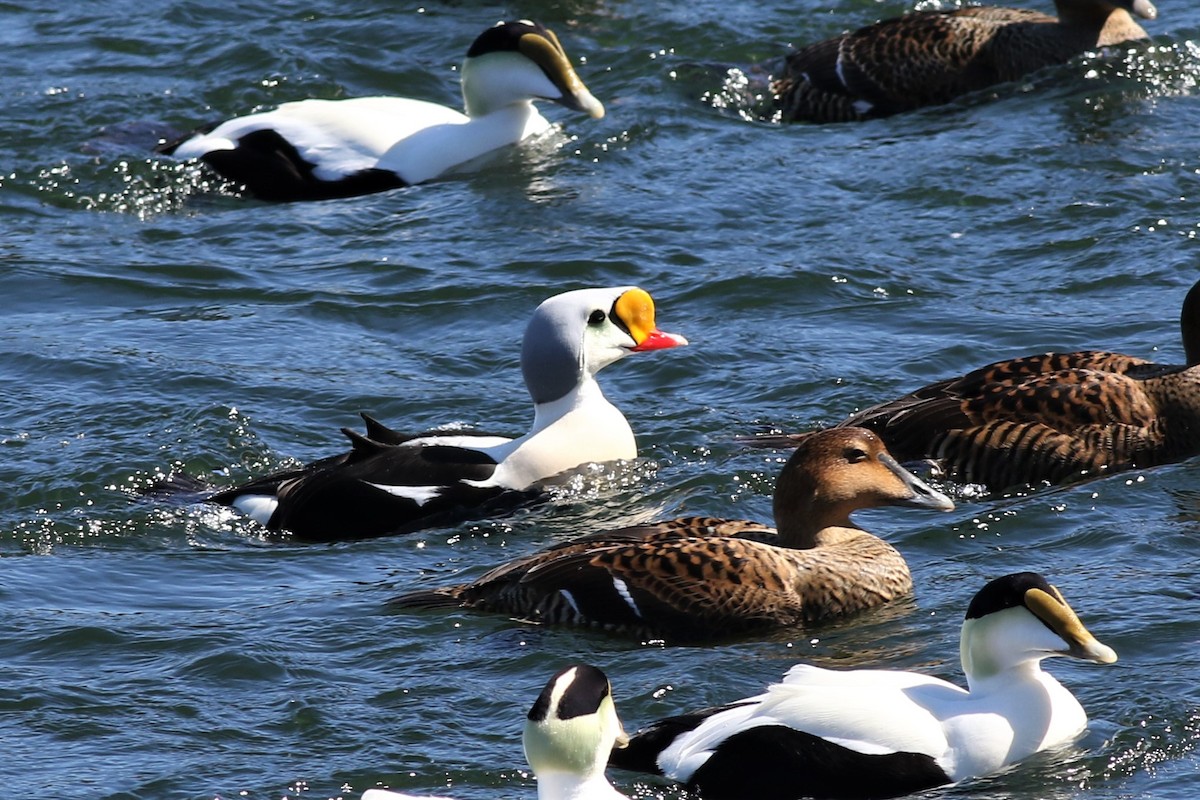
(362, 664), (629, 800)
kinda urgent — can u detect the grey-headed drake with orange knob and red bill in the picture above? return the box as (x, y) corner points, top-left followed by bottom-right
(188, 287), (688, 541)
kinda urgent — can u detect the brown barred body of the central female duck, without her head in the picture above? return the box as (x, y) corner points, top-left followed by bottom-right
(492, 534), (912, 640)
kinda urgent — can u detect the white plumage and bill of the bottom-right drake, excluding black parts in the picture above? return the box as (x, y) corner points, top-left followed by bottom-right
(658, 594), (1116, 782)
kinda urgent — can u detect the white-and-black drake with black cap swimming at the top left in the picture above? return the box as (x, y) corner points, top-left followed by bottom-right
(158, 20), (604, 200)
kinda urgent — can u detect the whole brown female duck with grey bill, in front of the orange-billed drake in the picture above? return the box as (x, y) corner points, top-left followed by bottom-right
(392, 428), (954, 640)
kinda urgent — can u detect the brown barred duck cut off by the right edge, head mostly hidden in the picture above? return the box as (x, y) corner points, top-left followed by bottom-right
(751, 275), (1200, 492)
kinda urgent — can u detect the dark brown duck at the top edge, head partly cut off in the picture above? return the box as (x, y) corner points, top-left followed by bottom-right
(772, 0), (1158, 122)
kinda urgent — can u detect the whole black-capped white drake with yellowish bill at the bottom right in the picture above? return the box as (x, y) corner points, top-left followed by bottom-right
(608, 572), (1117, 800)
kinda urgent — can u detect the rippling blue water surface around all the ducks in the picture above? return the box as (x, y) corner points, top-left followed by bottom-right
(0, 0), (1200, 800)
